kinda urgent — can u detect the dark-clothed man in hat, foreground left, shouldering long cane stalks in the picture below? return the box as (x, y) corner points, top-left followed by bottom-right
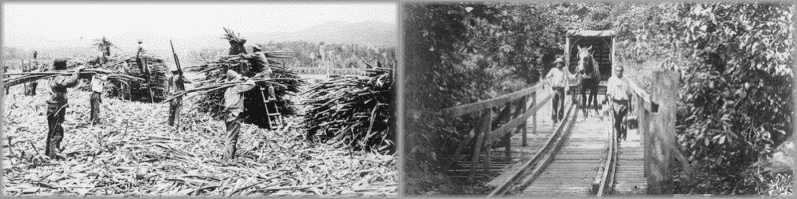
(44, 59), (83, 158)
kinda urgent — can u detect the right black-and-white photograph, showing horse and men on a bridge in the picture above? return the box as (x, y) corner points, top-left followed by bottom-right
(400, 3), (797, 197)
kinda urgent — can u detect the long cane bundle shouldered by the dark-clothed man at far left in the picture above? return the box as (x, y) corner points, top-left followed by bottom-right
(3, 69), (144, 86)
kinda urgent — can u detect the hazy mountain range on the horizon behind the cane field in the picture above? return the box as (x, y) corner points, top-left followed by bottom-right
(6, 21), (398, 56)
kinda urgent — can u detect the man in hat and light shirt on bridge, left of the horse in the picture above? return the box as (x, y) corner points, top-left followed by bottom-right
(545, 58), (569, 122)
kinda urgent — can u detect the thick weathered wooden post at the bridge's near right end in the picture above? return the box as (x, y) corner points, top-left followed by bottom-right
(643, 71), (679, 195)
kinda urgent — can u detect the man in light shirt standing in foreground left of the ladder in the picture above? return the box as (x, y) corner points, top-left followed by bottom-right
(222, 70), (255, 160)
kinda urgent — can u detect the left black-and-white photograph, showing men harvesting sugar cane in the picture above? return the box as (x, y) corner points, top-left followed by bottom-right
(0, 3), (398, 197)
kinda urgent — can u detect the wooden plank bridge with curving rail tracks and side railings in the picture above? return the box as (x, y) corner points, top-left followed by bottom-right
(443, 72), (686, 197)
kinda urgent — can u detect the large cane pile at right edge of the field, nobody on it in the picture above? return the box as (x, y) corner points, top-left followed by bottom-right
(303, 63), (396, 152)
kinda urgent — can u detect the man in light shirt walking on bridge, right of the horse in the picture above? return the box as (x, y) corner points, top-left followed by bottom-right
(606, 66), (631, 140)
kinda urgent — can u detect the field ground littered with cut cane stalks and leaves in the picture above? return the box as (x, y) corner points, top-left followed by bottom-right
(2, 72), (398, 197)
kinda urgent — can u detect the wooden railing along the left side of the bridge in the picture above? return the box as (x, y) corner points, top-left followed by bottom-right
(442, 77), (568, 180)
